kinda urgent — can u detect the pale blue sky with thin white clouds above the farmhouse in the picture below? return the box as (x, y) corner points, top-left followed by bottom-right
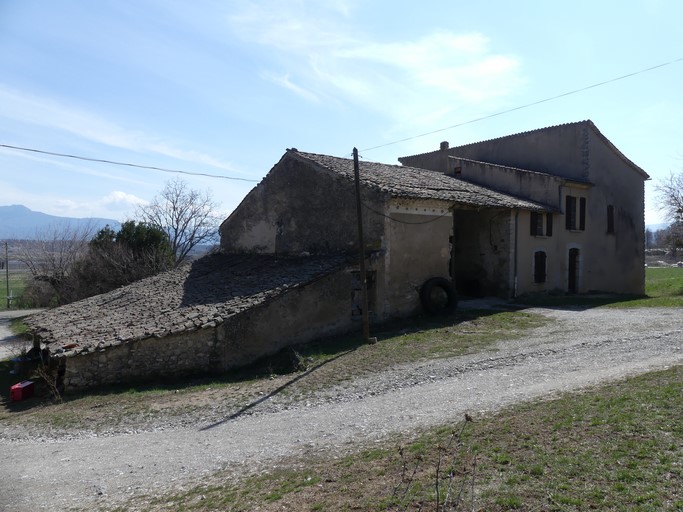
(0, 0), (683, 224)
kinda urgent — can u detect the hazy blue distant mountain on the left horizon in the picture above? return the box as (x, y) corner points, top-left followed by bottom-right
(0, 204), (121, 240)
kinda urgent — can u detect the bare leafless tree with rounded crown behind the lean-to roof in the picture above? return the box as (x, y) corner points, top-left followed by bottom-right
(137, 179), (221, 266)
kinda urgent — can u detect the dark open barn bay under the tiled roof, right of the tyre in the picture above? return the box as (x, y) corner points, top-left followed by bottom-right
(453, 210), (513, 297)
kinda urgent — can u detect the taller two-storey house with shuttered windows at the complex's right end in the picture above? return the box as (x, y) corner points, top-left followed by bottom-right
(399, 121), (649, 295)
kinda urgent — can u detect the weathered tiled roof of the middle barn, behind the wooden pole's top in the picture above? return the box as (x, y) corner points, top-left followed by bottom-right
(288, 150), (549, 211)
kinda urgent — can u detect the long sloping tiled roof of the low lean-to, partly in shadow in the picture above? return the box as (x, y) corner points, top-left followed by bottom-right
(26, 254), (345, 357)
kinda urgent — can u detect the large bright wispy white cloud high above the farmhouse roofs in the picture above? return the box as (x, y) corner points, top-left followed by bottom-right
(229, 0), (524, 127)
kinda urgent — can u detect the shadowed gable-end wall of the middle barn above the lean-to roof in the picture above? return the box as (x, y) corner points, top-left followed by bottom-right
(220, 154), (383, 254)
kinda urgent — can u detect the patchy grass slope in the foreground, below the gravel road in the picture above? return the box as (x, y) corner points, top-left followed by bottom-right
(123, 366), (683, 512)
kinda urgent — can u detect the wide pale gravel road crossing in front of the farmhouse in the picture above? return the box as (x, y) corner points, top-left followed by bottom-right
(0, 309), (683, 511)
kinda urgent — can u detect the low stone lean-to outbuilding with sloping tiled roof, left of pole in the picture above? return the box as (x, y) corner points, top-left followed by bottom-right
(26, 254), (352, 391)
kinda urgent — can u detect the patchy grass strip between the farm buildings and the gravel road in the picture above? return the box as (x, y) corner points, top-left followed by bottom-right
(0, 310), (548, 432)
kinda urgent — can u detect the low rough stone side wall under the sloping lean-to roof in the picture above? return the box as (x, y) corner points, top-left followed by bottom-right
(62, 270), (356, 393)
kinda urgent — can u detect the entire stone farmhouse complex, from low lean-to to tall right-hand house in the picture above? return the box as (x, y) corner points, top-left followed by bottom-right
(28, 121), (648, 391)
